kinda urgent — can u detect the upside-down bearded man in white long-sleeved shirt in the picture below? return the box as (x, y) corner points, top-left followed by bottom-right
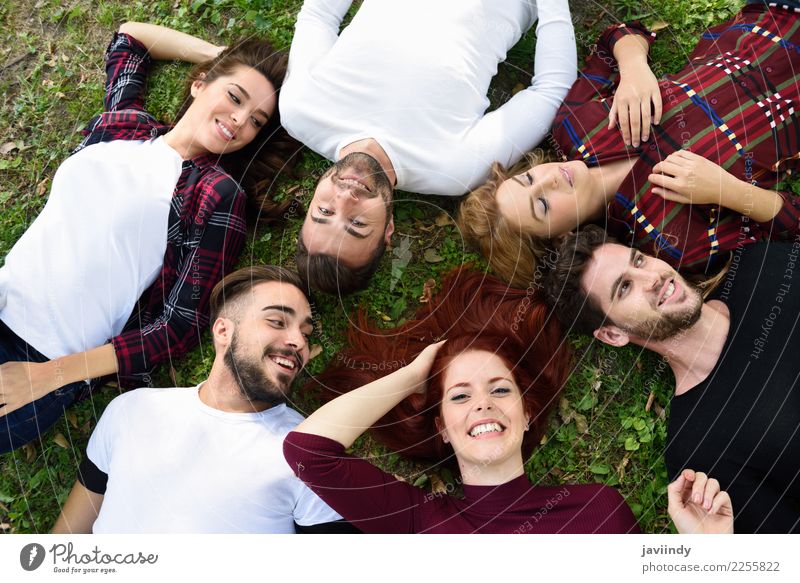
(279, 0), (577, 294)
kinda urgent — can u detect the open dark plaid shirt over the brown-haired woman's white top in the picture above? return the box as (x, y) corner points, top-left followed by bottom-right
(80, 34), (245, 386)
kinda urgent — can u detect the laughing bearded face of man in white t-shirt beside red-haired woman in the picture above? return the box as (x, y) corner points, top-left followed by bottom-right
(225, 281), (313, 404)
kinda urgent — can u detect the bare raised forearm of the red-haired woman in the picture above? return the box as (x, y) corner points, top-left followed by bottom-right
(295, 366), (421, 447)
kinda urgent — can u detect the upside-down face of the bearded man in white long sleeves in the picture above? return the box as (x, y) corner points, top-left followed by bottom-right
(300, 152), (394, 267)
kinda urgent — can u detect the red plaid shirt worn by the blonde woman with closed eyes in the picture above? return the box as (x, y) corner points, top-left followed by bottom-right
(553, 5), (800, 272)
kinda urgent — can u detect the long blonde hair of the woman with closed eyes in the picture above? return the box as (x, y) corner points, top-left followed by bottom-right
(456, 150), (553, 289)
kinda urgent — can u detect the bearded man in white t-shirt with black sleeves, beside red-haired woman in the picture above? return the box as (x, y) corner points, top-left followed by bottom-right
(53, 266), (352, 533)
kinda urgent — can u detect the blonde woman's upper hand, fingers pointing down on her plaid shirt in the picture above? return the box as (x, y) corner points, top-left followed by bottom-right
(608, 61), (662, 148)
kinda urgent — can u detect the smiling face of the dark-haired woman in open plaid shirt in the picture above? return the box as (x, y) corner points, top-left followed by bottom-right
(184, 65), (277, 155)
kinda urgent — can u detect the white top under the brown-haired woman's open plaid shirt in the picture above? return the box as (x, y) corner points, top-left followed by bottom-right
(0, 137), (183, 358)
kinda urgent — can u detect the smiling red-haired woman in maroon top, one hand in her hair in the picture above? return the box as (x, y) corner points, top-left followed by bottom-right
(284, 271), (732, 533)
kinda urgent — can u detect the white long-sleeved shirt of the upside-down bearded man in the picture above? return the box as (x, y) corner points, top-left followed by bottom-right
(280, 0), (577, 196)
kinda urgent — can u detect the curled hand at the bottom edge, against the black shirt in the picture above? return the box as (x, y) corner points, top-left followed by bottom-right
(667, 469), (733, 534)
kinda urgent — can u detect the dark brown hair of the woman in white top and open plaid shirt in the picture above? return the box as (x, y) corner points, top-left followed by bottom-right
(175, 38), (301, 224)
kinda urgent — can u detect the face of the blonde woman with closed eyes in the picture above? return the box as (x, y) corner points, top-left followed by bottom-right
(497, 161), (596, 239)
